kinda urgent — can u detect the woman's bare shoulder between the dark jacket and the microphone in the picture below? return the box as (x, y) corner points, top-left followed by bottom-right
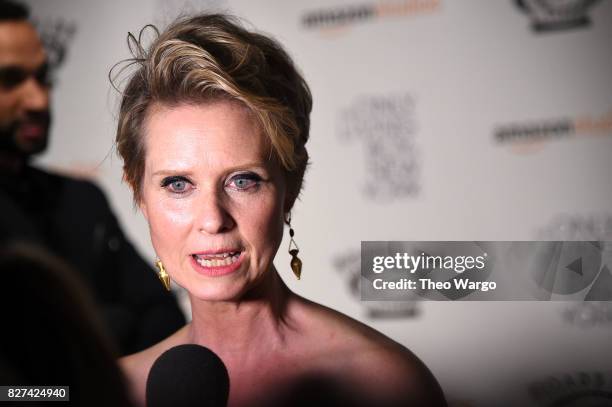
(119, 326), (187, 405)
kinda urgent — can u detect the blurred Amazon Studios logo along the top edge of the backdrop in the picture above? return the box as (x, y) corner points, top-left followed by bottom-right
(302, 0), (440, 29)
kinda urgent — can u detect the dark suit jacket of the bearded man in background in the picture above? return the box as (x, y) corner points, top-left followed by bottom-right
(0, 167), (185, 355)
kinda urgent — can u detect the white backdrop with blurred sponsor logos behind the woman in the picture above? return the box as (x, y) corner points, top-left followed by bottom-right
(22, 0), (612, 406)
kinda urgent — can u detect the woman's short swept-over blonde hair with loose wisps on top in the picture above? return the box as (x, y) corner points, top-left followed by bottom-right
(116, 14), (312, 210)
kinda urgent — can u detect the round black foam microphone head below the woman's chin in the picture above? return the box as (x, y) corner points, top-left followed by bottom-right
(147, 344), (229, 407)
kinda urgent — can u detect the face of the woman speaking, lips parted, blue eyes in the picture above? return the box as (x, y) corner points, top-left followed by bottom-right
(140, 101), (285, 301)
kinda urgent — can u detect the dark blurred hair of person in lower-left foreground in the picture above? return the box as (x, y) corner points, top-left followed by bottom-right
(0, 244), (131, 407)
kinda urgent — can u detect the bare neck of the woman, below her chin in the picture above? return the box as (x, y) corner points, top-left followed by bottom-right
(188, 267), (295, 363)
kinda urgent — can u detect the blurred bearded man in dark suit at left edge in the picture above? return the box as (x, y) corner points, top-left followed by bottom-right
(0, 0), (185, 354)
